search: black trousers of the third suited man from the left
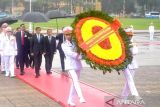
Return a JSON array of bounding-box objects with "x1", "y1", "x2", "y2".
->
[{"x1": 44, "y1": 53, "x2": 54, "y2": 72}]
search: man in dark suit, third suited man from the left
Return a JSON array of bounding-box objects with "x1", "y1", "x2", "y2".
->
[{"x1": 44, "y1": 29, "x2": 56, "y2": 74}]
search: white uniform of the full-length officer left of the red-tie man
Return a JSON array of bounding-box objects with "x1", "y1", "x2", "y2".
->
[{"x1": 1, "y1": 35, "x2": 17, "y2": 77}]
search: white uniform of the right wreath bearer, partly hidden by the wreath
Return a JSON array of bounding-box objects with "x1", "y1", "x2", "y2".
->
[{"x1": 121, "y1": 41, "x2": 139, "y2": 98}]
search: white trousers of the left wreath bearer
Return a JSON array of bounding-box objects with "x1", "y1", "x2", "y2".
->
[{"x1": 68, "y1": 70, "x2": 83, "y2": 101}]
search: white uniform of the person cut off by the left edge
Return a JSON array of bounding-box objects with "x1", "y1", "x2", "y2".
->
[{"x1": 0, "y1": 32, "x2": 5, "y2": 71}]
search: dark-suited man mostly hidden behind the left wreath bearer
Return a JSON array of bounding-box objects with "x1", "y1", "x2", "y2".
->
[{"x1": 56, "y1": 33, "x2": 65, "y2": 72}]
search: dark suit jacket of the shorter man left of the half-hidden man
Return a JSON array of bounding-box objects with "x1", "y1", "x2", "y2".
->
[{"x1": 44, "y1": 36, "x2": 56, "y2": 54}]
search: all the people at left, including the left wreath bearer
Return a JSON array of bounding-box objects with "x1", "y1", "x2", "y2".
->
[{"x1": 0, "y1": 23, "x2": 86, "y2": 106}]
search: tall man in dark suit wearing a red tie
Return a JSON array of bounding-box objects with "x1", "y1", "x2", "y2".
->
[{"x1": 16, "y1": 24, "x2": 30, "y2": 75}]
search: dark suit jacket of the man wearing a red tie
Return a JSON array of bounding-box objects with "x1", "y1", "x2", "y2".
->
[{"x1": 16, "y1": 31, "x2": 31, "y2": 53}]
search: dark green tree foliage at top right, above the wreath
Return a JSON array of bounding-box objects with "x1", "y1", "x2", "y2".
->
[{"x1": 102, "y1": 0, "x2": 160, "y2": 14}]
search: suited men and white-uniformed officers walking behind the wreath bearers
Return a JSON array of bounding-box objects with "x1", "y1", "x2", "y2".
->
[{"x1": 0, "y1": 23, "x2": 68, "y2": 78}]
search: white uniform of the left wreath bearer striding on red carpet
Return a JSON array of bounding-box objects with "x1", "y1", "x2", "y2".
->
[{"x1": 62, "y1": 40, "x2": 83, "y2": 102}]
